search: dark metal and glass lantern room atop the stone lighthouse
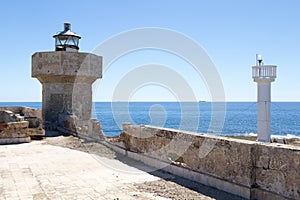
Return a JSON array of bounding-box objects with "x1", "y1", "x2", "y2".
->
[{"x1": 53, "y1": 23, "x2": 81, "y2": 52}]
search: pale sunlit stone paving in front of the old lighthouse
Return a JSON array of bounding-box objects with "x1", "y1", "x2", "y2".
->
[{"x1": 0, "y1": 141, "x2": 164, "y2": 200}]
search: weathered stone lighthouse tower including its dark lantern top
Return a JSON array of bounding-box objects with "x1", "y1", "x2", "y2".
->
[{"x1": 32, "y1": 23, "x2": 102, "y2": 137}]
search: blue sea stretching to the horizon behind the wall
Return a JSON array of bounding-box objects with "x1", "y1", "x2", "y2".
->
[{"x1": 0, "y1": 101, "x2": 300, "y2": 138}]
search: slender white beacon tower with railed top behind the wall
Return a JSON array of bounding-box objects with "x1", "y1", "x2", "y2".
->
[{"x1": 252, "y1": 54, "x2": 277, "y2": 142}]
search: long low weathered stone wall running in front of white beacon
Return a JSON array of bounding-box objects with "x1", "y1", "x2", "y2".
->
[{"x1": 120, "y1": 124, "x2": 300, "y2": 199}]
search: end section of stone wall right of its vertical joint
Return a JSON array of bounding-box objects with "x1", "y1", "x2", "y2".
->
[{"x1": 254, "y1": 144, "x2": 300, "y2": 199}]
